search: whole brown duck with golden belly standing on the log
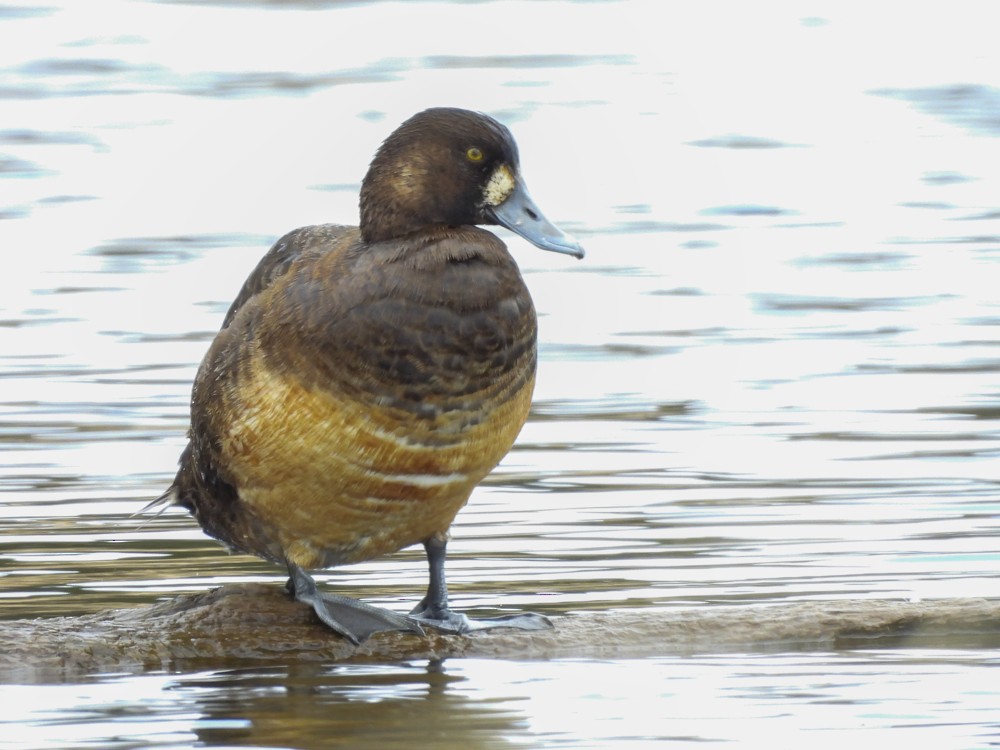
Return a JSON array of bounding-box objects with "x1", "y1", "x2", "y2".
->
[{"x1": 151, "y1": 107, "x2": 584, "y2": 644}]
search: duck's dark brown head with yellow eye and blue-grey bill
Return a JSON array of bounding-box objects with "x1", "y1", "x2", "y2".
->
[{"x1": 361, "y1": 108, "x2": 583, "y2": 258}]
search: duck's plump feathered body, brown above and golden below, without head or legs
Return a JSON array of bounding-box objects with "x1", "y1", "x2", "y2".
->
[{"x1": 175, "y1": 225, "x2": 536, "y2": 568}]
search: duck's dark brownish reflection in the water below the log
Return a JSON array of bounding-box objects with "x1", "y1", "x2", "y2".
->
[{"x1": 167, "y1": 662, "x2": 524, "y2": 748}]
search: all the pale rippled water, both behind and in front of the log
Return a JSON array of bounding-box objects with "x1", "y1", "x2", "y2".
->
[{"x1": 0, "y1": 0, "x2": 1000, "y2": 748}]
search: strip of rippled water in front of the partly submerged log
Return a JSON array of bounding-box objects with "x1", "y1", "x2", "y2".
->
[{"x1": 0, "y1": 649, "x2": 1000, "y2": 750}]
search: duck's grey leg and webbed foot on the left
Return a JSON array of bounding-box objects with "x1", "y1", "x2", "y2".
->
[{"x1": 287, "y1": 562, "x2": 424, "y2": 646}]
